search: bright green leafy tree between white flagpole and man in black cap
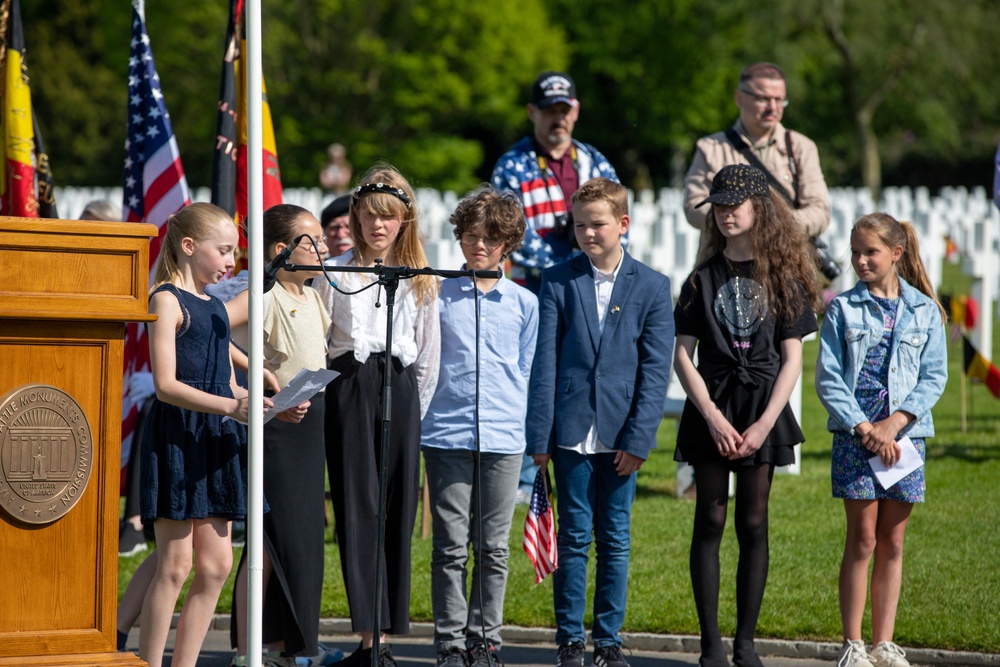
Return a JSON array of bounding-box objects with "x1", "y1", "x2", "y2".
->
[{"x1": 264, "y1": 0, "x2": 566, "y2": 191}]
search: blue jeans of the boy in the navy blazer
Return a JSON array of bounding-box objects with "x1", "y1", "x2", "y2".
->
[{"x1": 552, "y1": 449, "x2": 636, "y2": 648}]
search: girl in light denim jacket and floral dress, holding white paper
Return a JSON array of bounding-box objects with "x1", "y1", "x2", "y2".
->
[{"x1": 816, "y1": 213, "x2": 948, "y2": 667}]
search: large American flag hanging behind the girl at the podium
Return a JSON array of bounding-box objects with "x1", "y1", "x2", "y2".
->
[{"x1": 122, "y1": 0, "x2": 191, "y2": 478}]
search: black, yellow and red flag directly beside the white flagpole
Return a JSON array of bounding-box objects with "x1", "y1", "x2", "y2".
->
[{"x1": 212, "y1": 0, "x2": 282, "y2": 273}]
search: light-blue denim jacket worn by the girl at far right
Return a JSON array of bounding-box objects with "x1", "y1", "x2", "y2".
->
[{"x1": 816, "y1": 278, "x2": 948, "y2": 438}]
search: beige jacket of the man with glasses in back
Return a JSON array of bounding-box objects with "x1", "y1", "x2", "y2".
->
[{"x1": 684, "y1": 121, "x2": 830, "y2": 243}]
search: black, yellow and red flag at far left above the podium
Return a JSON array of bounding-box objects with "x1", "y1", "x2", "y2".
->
[{"x1": 0, "y1": 0, "x2": 59, "y2": 218}]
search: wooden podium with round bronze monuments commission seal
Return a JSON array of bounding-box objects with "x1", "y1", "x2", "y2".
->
[{"x1": 0, "y1": 217, "x2": 157, "y2": 667}]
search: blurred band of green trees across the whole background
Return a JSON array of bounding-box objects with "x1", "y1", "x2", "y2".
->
[{"x1": 22, "y1": 0, "x2": 1000, "y2": 196}]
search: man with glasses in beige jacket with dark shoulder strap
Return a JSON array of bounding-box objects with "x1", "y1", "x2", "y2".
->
[{"x1": 684, "y1": 63, "x2": 830, "y2": 245}]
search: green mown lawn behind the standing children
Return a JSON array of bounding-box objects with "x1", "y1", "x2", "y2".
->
[{"x1": 119, "y1": 267, "x2": 1000, "y2": 653}]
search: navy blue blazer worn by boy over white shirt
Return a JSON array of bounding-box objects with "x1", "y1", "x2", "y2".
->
[{"x1": 526, "y1": 252, "x2": 674, "y2": 459}]
